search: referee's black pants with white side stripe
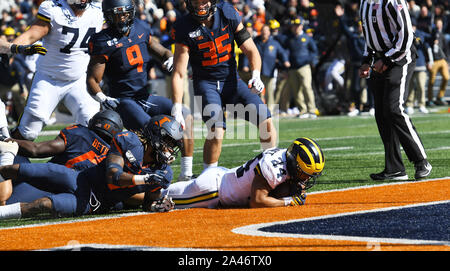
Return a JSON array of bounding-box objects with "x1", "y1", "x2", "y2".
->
[{"x1": 368, "y1": 53, "x2": 427, "y2": 173}]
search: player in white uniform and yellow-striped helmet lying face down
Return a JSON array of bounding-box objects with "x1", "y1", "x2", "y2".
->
[{"x1": 161, "y1": 137, "x2": 325, "y2": 209}]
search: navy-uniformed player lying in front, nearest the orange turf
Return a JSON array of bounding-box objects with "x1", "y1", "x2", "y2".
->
[{"x1": 0, "y1": 115, "x2": 183, "y2": 219}]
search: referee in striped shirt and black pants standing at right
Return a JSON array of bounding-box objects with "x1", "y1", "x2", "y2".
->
[{"x1": 359, "y1": 0, "x2": 432, "y2": 183}]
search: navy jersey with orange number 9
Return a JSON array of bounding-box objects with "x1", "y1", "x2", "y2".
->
[{"x1": 89, "y1": 19, "x2": 153, "y2": 98}]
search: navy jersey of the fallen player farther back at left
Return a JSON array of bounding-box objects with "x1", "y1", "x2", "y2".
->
[{"x1": 49, "y1": 125, "x2": 109, "y2": 170}]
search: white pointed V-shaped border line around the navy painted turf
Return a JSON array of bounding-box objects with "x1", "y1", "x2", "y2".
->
[{"x1": 231, "y1": 200, "x2": 450, "y2": 246}]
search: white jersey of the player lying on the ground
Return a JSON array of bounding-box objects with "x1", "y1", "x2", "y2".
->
[{"x1": 219, "y1": 148, "x2": 288, "y2": 206}]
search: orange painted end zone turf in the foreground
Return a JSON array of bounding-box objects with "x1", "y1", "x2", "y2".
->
[{"x1": 0, "y1": 179, "x2": 450, "y2": 251}]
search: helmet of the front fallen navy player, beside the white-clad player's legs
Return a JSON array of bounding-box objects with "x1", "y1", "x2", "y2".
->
[{"x1": 143, "y1": 115, "x2": 183, "y2": 164}]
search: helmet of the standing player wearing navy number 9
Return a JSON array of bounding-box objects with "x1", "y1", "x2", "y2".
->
[{"x1": 102, "y1": 0, "x2": 135, "y2": 35}]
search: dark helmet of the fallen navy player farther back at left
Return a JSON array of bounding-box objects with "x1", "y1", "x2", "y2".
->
[{"x1": 88, "y1": 110, "x2": 123, "y2": 143}]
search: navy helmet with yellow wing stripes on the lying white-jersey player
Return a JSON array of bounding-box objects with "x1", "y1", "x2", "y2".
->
[{"x1": 286, "y1": 137, "x2": 325, "y2": 190}]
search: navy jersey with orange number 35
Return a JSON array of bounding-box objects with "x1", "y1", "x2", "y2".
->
[{"x1": 172, "y1": 2, "x2": 241, "y2": 80}]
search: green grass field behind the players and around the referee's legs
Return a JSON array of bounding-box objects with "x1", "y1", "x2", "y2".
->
[{"x1": 0, "y1": 107, "x2": 450, "y2": 230}]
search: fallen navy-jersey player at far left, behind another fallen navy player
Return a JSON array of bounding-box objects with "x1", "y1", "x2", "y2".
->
[{"x1": 0, "y1": 110, "x2": 123, "y2": 205}]
